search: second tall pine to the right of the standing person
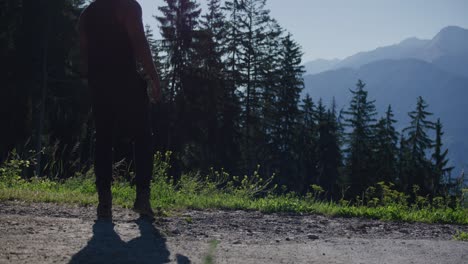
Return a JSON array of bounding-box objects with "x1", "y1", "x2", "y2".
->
[{"x1": 199, "y1": 0, "x2": 240, "y2": 170}]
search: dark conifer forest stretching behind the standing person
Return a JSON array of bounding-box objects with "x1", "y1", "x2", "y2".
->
[{"x1": 0, "y1": 0, "x2": 457, "y2": 200}]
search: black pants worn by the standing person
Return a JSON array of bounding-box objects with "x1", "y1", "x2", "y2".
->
[{"x1": 90, "y1": 75, "x2": 153, "y2": 189}]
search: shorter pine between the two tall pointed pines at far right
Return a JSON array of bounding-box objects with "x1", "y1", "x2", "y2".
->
[{"x1": 374, "y1": 105, "x2": 398, "y2": 183}]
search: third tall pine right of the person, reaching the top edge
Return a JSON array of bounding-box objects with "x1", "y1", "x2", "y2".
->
[{"x1": 225, "y1": 0, "x2": 277, "y2": 171}]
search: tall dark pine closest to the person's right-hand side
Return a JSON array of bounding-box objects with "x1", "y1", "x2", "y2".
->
[{"x1": 155, "y1": 0, "x2": 204, "y2": 171}]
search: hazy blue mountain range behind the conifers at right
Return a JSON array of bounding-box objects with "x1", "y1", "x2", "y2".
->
[{"x1": 303, "y1": 26, "x2": 468, "y2": 176}]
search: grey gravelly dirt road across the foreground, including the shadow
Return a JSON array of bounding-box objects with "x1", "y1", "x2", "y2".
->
[{"x1": 0, "y1": 202, "x2": 468, "y2": 264}]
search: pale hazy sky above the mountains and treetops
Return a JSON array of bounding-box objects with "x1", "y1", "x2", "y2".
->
[{"x1": 137, "y1": 0, "x2": 468, "y2": 61}]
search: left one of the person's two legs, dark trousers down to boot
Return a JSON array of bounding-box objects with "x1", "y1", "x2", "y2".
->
[{"x1": 94, "y1": 106, "x2": 113, "y2": 218}]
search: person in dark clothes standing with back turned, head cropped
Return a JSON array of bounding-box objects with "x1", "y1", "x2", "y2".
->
[{"x1": 79, "y1": 0, "x2": 161, "y2": 219}]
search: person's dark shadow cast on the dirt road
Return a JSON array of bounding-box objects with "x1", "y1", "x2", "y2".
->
[{"x1": 69, "y1": 219, "x2": 190, "y2": 264}]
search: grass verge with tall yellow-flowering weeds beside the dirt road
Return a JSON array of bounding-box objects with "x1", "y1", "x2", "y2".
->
[{"x1": 0, "y1": 157, "x2": 468, "y2": 225}]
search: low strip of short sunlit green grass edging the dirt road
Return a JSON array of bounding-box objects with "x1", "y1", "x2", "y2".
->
[{"x1": 0, "y1": 173, "x2": 468, "y2": 225}]
